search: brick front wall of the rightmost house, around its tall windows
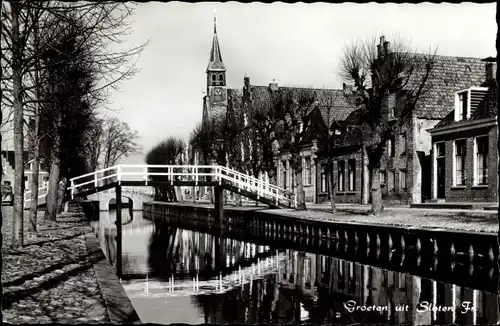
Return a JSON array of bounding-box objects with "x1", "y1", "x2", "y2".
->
[{"x1": 431, "y1": 126, "x2": 498, "y2": 202}]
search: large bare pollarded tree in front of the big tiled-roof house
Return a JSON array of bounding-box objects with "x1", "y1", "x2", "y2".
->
[{"x1": 341, "y1": 37, "x2": 435, "y2": 215}]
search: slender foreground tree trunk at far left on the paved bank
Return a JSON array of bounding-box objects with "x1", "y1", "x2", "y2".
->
[{"x1": 10, "y1": 2, "x2": 24, "y2": 248}]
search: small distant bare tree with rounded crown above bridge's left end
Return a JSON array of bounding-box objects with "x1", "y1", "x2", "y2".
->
[{"x1": 102, "y1": 117, "x2": 140, "y2": 168}]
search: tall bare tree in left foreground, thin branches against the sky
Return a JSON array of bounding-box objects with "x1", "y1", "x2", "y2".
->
[{"x1": 2, "y1": 1, "x2": 144, "y2": 241}]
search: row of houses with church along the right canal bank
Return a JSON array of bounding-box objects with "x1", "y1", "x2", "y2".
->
[{"x1": 203, "y1": 19, "x2": 498, "y2": 204}]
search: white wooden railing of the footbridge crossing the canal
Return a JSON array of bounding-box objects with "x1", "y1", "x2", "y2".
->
[{"x1": 70, "y1": 164, "x2": 297, "y2": 207}]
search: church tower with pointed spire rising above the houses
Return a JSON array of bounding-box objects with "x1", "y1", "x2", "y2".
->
[{"x1": 203, "y1": 17, "x2": 227, "y2": 121}]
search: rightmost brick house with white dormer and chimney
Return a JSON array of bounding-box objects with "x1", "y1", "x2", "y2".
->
[{"x1": 429, "y1": 58, "x2": 498, "y2": 202}]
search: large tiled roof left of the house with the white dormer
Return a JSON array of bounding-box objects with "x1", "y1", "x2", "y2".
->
[{"x1": 408, "y1": 54, "x2": 485, "y2": 119}]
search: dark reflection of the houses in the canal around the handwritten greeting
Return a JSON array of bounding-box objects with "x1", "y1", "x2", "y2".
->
[{"x1": 192, "y1": 250, "x2": 499, "y2": 325}]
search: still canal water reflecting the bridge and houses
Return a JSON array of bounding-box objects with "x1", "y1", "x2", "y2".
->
[{"x1": 92, "y1": 209, "x2": 500, "y2": 325}]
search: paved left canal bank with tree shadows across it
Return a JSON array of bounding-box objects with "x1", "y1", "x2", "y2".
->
[{"x1": 2, "y1": 207, "x2": 140, "y2": 324}]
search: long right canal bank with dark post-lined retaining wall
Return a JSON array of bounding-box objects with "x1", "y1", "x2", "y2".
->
[{"x1": 144, "y1": 202, "x2": 498, "y2": 265}]
